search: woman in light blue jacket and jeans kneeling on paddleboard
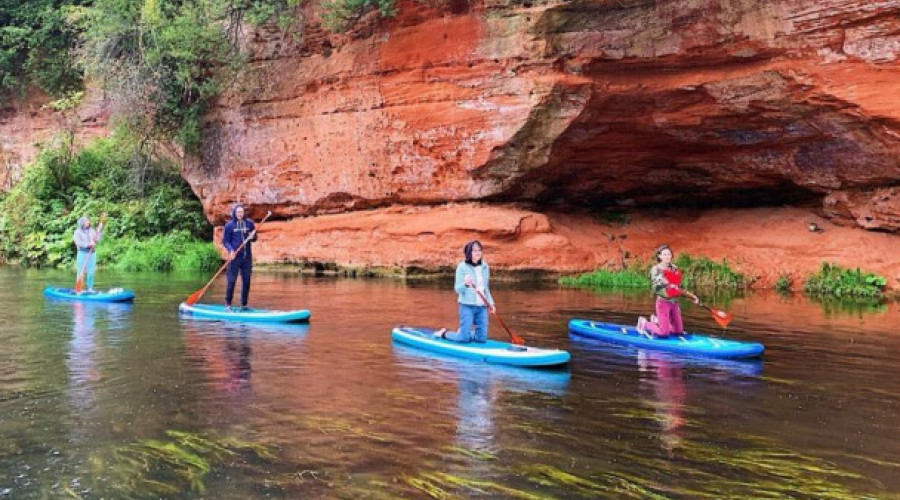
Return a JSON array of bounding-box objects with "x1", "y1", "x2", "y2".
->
[{"x1": 435, "y1": 240, "x2": 497, "y2": 343}]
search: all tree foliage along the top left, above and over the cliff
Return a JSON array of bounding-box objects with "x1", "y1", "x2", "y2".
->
[{"x1": 0, "y1": 0, "x2": 396, "y2": 153}]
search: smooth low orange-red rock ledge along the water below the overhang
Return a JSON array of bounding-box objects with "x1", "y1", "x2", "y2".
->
[{"x1": 227, "y1": 203, "x2": 900, "y2": 290}]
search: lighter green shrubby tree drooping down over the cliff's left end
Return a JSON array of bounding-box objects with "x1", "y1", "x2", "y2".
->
[{"x1": 81, "y1": 0, "x2": 299, "y2": 153}]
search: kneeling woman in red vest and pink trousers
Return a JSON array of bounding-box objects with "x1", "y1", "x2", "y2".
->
[{"x1": 637, "y1": 245, "x2": 700, "y2": 337}]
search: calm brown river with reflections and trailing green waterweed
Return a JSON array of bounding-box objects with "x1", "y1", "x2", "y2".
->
[{"x1": 0, "y1": 267, "x2": 900, "y2": 499}]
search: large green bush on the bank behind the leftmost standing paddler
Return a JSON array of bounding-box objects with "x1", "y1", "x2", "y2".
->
[{"x1": 0, "y1": 133, "x2": 212, "y2": 269}]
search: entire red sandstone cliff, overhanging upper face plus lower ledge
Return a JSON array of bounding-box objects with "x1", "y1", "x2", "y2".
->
[{"x1": 0, "y1": 0, "x2": 900, "y2": 286}]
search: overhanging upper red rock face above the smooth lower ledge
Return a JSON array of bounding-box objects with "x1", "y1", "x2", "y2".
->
[{"x1": 185, "y1": 0, "x2": 900, "y2": 222}]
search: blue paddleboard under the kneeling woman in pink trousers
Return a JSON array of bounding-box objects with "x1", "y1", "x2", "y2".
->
[{"x1": 569, "y1": 319, "x2": 766, "y2": 359}]
